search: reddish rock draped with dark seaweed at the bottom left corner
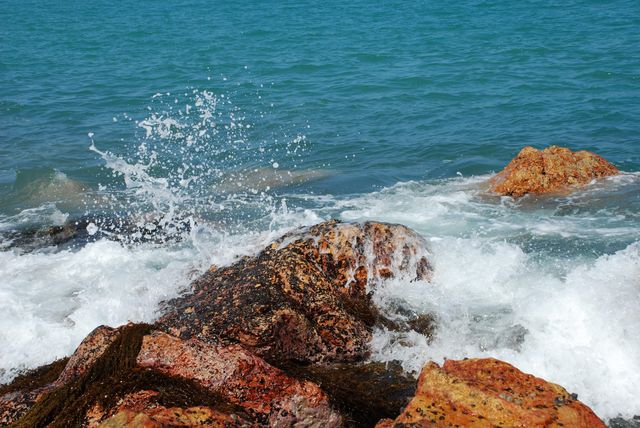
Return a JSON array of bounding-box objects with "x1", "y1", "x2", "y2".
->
[{"x1": 0, "y1": 324, "x2": 342, "y2": 427}]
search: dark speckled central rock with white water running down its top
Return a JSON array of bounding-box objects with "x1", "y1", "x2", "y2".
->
[{"x1": 158, "y1": 221, "x2": 431, "y2": 364}]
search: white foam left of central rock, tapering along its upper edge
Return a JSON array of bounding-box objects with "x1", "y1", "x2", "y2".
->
[{"x1": 0, "y1": 203, "x2": 323, "y2": 383}]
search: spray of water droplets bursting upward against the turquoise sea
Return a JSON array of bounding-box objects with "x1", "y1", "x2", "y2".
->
[{"x1": 87, "y1": 89, "x2": 316, "y2": 242}]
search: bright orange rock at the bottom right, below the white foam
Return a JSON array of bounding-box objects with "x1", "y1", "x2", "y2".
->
[{"x1": 377, "y1": 358, "x2": 605, "y2": 428}]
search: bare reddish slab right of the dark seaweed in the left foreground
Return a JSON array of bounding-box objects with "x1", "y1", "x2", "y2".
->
[{"x1": 137, "y1": 332, "x2": 341, "y2": 427}]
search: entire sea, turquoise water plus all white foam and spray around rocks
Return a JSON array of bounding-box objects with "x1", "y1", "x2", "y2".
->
[{"x1": 0, "y1": 0, "x2": 640, "y2": 418}]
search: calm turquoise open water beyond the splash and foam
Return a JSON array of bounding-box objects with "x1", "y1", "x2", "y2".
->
[{"x1": 0, "y1": 1, "x2": 640, "y2": 194}]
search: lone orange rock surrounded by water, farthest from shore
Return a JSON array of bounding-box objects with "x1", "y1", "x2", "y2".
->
[{"x1": 490, "y1": 146, "x2": 619, "y2": 197}]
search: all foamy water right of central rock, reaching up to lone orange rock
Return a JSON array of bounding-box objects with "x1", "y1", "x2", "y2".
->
[{"x1": 292, "y1": 173, "x2": 640, "y2": 418}]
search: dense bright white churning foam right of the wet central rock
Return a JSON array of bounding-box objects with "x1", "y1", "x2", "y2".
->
[{"x1": 373, "y1": 238, "x2": 640, "y2": 418}]
